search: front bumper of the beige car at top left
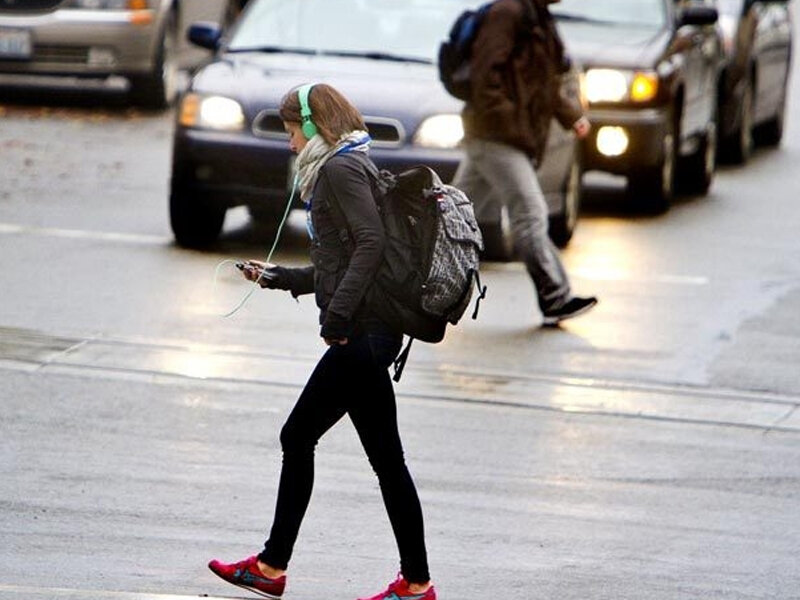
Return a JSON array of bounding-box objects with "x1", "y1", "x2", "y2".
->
[{"x1": 0, "y1": 9, "x2": 158, "y2": 77}]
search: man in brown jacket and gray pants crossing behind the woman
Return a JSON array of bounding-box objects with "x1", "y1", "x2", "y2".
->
[{"x1": 453, "y1": 0, "x2": 597, "y2": 326}]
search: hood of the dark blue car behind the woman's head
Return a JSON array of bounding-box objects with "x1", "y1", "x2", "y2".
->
[{"x1": 191, "y1": 52, "x2": 462, "y2": 118}]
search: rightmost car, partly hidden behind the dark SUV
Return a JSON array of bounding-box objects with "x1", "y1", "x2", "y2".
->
[{"x1": 717, "y1": 0, "x2": 792, "y2": 163}]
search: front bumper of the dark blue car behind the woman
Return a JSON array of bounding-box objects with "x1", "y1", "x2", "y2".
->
[{"x1": 172, "y1": 126, "x2": 462, "y2": 212}]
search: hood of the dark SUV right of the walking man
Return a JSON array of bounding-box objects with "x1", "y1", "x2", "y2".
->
[{"x1": 559, "y1": 23, "x2": 670, "y2": 69}]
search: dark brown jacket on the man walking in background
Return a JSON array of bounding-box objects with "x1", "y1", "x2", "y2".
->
[{"x1": 463, "y1": 0, "x2": 583, "y2": 164}]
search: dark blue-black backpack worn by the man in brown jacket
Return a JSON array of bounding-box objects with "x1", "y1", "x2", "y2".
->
[{"x1": 439, "y1": 2, "x2": 493, "y2": 100}]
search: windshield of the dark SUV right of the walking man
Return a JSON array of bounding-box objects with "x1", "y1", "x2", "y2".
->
[{"x1": 550, "y1": 0, "x2": 667, "y2": 28}]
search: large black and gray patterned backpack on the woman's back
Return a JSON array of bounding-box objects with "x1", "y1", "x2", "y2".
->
[{"x1": 328, "y1": 152, "x2": 486, "y2": 381}]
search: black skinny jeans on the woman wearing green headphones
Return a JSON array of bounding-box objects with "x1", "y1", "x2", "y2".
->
[{"x1": 258, "y1": 334, "x2": 430, "y2": 583}]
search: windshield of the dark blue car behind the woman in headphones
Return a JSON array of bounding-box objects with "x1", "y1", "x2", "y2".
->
[{"x1": 228, "y1": 0, "x2": 480, "y2": 63}]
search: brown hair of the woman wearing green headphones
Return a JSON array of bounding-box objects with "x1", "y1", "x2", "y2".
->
[{"x1": 278, "y1": 83, "x2": 367, "y2": 146}]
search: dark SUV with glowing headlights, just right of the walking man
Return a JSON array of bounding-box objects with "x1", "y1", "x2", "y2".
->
[{"x1": 550, "y1": 0, "x2": 723, "y2": 212}]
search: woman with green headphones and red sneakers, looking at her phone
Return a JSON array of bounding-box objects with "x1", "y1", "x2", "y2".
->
[{"x1": 203, "y1": 84, "x2": 436, "y2": 600}]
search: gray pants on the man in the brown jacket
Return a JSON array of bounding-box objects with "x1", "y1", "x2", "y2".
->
[{"x1": 453, "y1": 140, "x2": 570, "y2": 312}]
